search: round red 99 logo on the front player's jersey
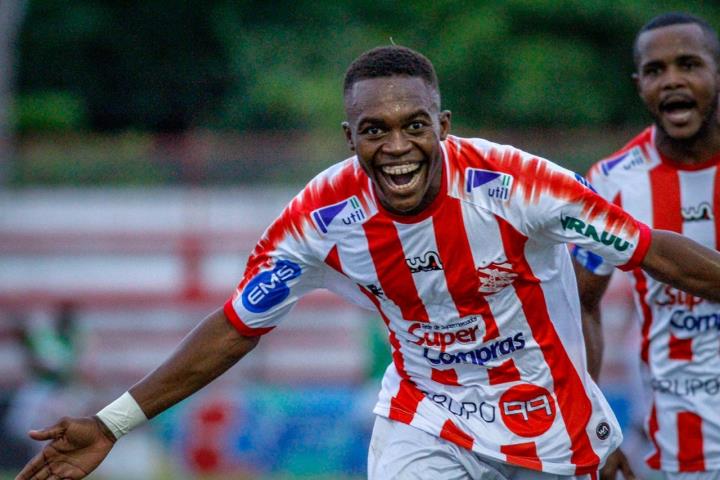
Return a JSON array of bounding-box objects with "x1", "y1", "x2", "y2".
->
[{"x1": 499, "y1": 383, "x2": 556, "y2": 437}]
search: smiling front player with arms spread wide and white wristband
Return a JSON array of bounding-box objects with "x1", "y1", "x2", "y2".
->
[{"x1": 18, "y1": 46, "x2": 720, "y2": 480}]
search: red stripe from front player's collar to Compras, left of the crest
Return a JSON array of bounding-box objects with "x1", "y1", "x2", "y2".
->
[{"x1": 433, "y1": 198, "x2": 500, "y2": 342}]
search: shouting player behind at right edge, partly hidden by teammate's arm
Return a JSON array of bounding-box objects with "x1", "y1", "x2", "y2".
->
[{"x1": 574, "y1": 13, "x2": 720, "y2": 480}]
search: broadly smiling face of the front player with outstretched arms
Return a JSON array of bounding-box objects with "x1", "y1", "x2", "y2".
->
[{"x1": 343, "y1": 76, "x2": 450, "y2": 215}]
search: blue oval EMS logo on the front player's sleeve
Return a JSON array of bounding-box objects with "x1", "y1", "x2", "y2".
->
[{"x1": 242, "y1": 260, "x2": 302, "y2": 313}]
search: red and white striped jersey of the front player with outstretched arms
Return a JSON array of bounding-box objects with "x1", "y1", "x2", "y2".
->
[{"x1": 225, "y1": 137, "x2": 650, "y2": 475}]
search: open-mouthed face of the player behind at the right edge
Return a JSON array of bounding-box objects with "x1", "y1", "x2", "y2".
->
[{"x1": 635, "y1": 24, "x2": 720, "y2": 140}]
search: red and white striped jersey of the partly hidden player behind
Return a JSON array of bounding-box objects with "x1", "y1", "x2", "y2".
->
[{"x1": 576, "y1": 127, "x2": 720, "y2": 472}]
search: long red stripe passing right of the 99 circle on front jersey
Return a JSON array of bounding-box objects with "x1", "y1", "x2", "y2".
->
[{"x1": 496, "y1": 216, "x2": 600, "y2": 475}]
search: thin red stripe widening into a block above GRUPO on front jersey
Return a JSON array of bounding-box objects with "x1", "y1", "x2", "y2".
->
[{"x1": 360, "y1": 287, "x2": 425, "y2": 424}]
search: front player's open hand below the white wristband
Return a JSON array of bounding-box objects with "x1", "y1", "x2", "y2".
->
[{"x1": 15, "y1": 417, "x2": 115, "y2": 480}]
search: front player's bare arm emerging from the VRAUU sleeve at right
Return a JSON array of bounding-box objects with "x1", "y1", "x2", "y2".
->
[{"x1": 640, "y1": 230, "x2": 720, "y2": 302}]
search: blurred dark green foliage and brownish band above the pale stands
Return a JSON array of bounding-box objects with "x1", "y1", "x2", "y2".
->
[{"x1": 11, "y1": 0, "x2": 720, "y2": 185}]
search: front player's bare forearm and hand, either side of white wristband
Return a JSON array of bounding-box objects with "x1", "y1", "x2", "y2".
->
[{"x1": 16, "y1": 309, "x2": 259, "y2": 480}]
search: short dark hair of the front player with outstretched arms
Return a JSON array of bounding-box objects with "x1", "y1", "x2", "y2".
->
[{"x1": 343, "y1": 45, "x2": 439, "y2": 94}]
